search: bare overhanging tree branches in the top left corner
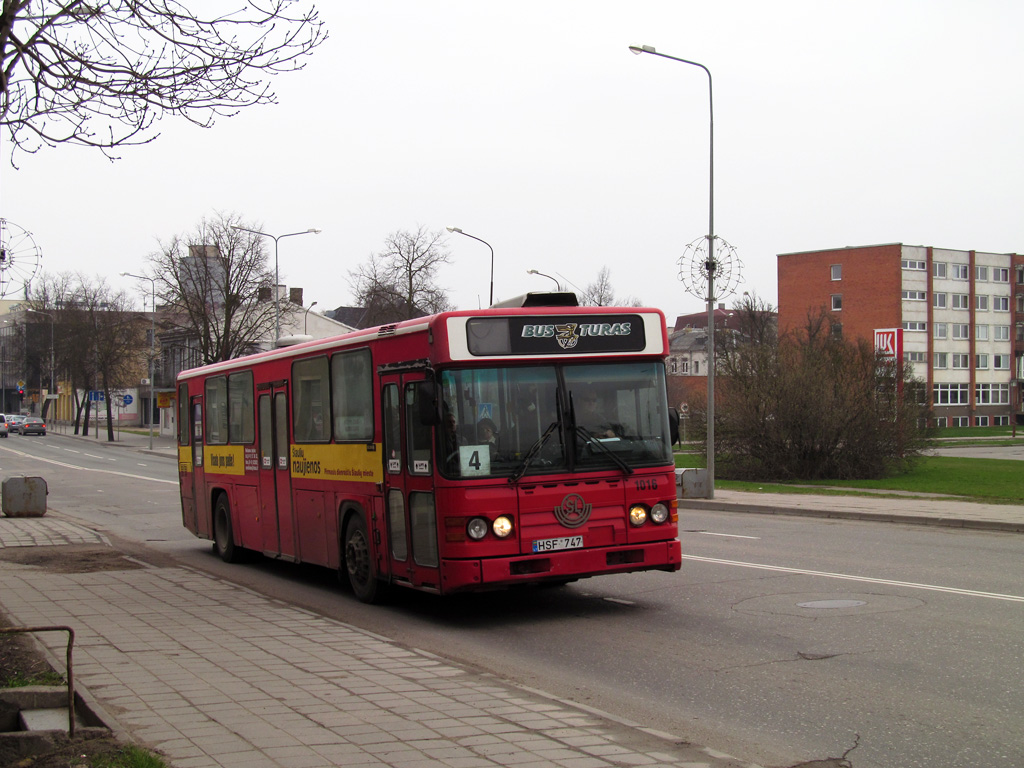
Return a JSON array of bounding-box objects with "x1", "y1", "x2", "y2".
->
[{"x1": 0, "y1": 0, "x2": 327, "y2": 159}]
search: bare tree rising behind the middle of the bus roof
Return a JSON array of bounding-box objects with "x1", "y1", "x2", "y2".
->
[{"x1": 348, "y1": 226, "x2": 454, "y2": 326}]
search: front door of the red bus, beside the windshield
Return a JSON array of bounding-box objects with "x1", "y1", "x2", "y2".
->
[{"x1": 378, "y1": 373, "x2": 440, "y2": 590}]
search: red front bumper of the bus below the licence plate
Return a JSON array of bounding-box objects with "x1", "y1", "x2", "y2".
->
[{"x1": 441, "y1": 540, "x2": 682, "y2": 594}]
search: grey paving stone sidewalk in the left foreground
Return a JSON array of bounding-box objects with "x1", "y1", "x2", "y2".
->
[{"x1": 0, "y1": 516, "x2": 756, "y2": 768}]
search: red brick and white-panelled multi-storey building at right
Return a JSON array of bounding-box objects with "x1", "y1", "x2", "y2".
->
[{"x1": 778, "y1": 243, "x2": 1024, "y2": 426}]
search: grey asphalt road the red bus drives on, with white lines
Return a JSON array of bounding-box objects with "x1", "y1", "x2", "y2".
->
[{"x1": 0, "y1": 437, "x2": 1024, "y2": 768}]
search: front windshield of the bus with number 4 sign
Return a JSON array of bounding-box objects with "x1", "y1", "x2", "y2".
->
[{"x1": 437, "y1": 361, "x2": 672, "y2": 479}]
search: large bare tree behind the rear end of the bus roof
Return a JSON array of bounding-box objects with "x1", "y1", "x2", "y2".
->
[{"x1": 150, "y1": 213, "x2": 276, "y2": 365}]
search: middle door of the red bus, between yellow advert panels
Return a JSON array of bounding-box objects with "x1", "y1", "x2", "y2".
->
[{"x1": 257, "y1": 383, "x2": 295, "y2": 559}]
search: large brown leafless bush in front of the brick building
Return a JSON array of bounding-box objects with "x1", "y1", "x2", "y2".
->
[{"x1": 708, "y1": 302, "x2": 928, "y2": 480}]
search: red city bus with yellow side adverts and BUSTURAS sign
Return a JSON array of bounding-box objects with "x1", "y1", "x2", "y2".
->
[{"x1": 177, "y1": 294, "x2": 681, "y2": 602}]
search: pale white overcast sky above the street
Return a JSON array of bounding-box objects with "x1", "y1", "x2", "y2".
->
[{"x1": 0, "y1": 0, "x2": 1024, "y2": 319}]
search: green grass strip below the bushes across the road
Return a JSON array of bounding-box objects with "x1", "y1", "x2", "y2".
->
[{"x1": 676, "y1": 454, "x2": 1024, "y2": 504}]
